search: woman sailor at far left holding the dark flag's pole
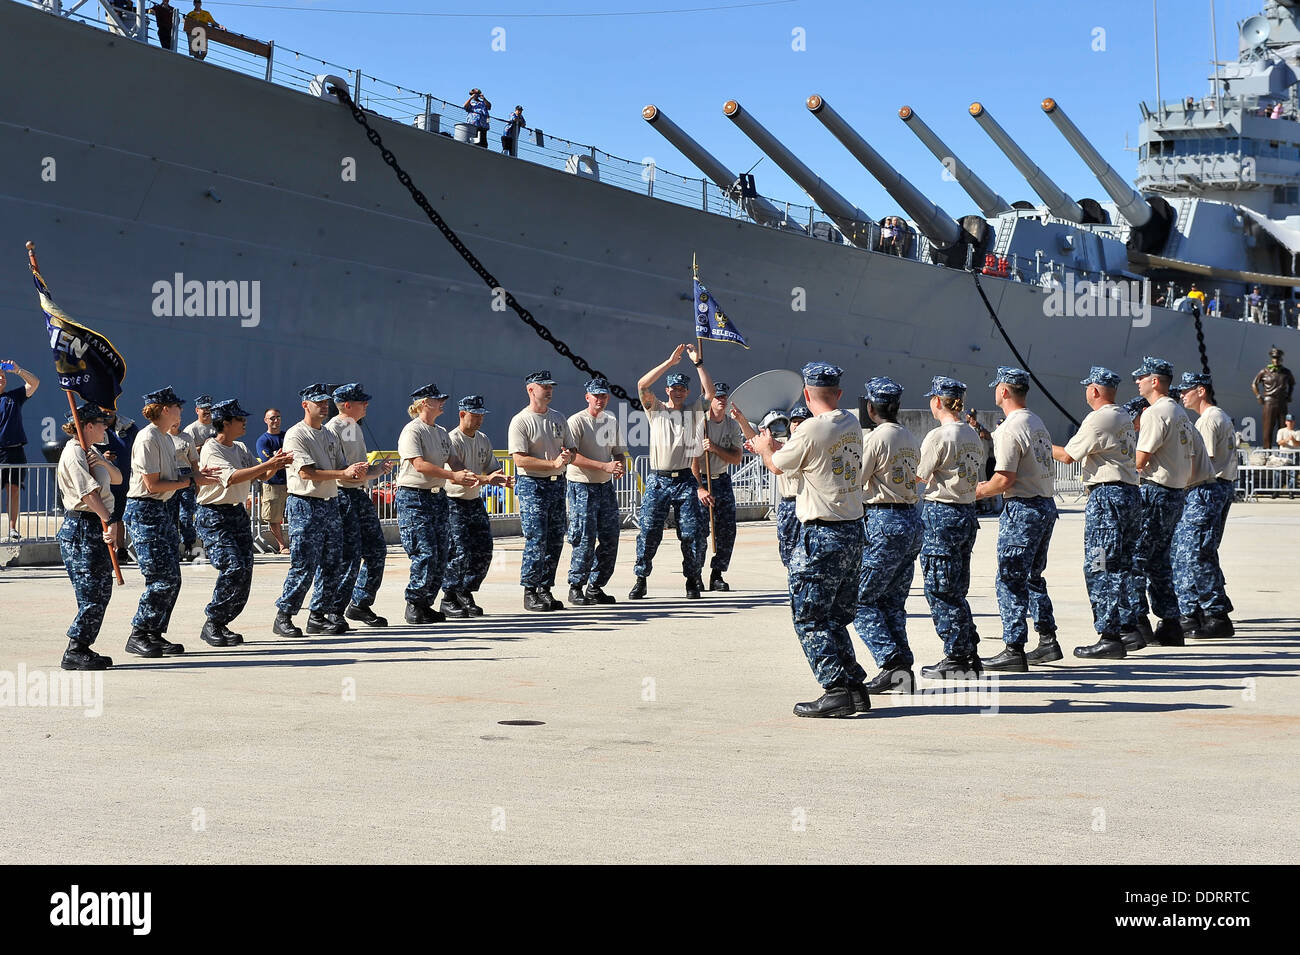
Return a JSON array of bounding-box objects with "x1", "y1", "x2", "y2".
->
[{"x1": 56, "y1": 401, "x2": 122, "y2": 670}]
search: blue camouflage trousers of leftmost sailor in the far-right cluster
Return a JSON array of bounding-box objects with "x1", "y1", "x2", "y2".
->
[{"x1": 1083, "y1": 483, "x2": 1141, "y2": 637}]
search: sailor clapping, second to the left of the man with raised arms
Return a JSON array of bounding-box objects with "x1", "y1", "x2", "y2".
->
[{"x1": 506, "y1": 370, "x2": 573, "y2": 612}]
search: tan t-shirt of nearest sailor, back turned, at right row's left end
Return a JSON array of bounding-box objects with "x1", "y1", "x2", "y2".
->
[{"x1": 772, "y1": 409, "x2": 862, "y2": 521}]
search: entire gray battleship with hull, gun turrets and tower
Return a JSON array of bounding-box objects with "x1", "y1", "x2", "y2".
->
[{"x1": 0, "y1": 0, "x2": 1300, "y2": 444}]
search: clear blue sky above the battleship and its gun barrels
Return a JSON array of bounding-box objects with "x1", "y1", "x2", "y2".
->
[{"x1": 152, "y1": 0, "x2": 1262, "y2": 217}]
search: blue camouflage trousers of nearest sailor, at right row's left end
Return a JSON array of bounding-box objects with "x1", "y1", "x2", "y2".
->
[{"x1": 790, "y1": 521, "x2": 867, "y2": 687}]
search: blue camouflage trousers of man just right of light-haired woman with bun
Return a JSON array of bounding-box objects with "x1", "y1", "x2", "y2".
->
[{"x1": 996, "y1": 498, "x2": 1057, "y2": 646}]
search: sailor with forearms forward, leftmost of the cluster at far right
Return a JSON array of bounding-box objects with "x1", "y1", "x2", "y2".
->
[{"x1": 1050, "y1": 365, "x2": 1147, "y2": 663}]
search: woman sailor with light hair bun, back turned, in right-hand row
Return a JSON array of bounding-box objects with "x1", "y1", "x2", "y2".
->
[{"x1": 917, "y1": 376, "x2": 984, "y2": 680}]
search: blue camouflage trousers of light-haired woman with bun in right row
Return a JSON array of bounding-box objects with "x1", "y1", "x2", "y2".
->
[{"x1": 920, "y1": 500, "x2": 979, "y2": 657}]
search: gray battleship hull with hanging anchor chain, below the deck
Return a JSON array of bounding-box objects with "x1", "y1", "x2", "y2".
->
[{"x1": 0, "y1": 3, "x2": 1291, "y2": 447}]
